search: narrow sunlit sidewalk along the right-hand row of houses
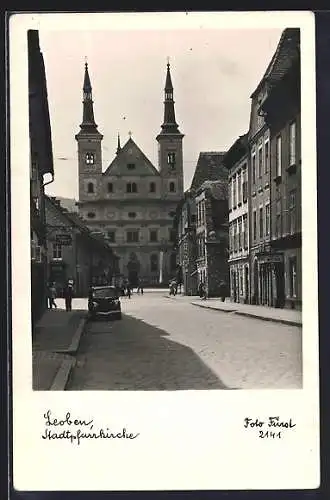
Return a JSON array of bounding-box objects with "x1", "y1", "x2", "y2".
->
[{"x1": 166, "y1": 295, "x2": 302, "y2": 327}]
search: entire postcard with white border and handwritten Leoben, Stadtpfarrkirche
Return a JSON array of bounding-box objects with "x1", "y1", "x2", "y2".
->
[{"x1": 10, "y1": 12, "x2": 319, "y2": 491}]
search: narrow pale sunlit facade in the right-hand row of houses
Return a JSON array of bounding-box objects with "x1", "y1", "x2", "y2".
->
[{"x1": 224, "y1": 134, "x2": 250, "y2": 304}]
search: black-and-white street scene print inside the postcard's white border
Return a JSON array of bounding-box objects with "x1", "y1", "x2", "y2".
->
[{"x1": 27, "y1": 23, "x2": 302, "y2": 391}]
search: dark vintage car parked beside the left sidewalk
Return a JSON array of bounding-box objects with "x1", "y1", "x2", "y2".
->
[{"x1": 88, "y1": 286, "x2": 121, "y2": 319}]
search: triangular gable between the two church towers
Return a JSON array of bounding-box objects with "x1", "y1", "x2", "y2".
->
[{"x1": 104, "y1": 138, "x2": 159, "y2": 177}]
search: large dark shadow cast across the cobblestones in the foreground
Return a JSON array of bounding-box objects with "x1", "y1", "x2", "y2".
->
[{"x1": 66, "y1": 314, "x2": 235, "y2": 391}]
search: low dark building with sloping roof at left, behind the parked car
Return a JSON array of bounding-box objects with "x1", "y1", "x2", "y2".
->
[{"x1": 45, "y1": 197, "x2": 118, "y2": 297}]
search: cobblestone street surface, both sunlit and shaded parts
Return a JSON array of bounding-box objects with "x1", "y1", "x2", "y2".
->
[{"x1": 67, "y1": 294, "x2": 302, "y2": 390}]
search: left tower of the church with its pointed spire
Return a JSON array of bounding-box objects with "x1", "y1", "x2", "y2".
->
[{"x1": 75, "y1": 62, "x2": 103, "y2": 202}]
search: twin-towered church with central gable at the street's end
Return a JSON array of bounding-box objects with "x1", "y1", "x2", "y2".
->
[{"x1": 75, "y1": 63, "x2": 184, "y2": 286}]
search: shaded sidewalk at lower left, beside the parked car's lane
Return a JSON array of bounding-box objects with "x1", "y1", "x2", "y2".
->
[{"x1": 32, "y1": 299, "x2": 86, "y2": 391}]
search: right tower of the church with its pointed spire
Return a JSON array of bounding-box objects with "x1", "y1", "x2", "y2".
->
[{"x1": 156, "y1": 62, "x2": 184, "y2": 200}]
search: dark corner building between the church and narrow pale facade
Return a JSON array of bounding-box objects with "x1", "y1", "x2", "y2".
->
[{"x1": 195, "y1": 179, "x2": 229, "y2": 297}]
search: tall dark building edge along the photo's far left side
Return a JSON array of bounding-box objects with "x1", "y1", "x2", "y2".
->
[{"x1": 28, "y1": 30, "x2": 54, "y2": 324}]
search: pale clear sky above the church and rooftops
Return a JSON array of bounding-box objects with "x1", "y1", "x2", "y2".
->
[{"x1": 39, "y1": 29, "x2": 282, "y2": 199}]
